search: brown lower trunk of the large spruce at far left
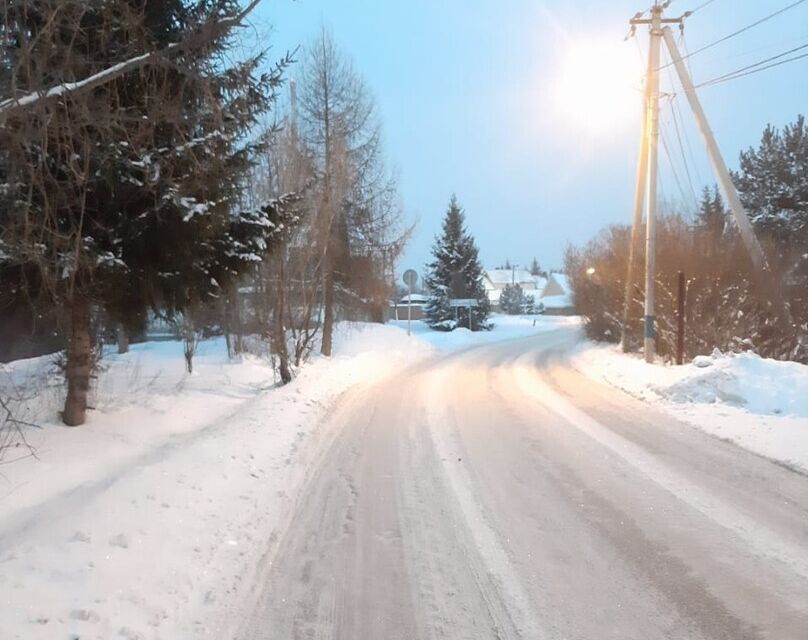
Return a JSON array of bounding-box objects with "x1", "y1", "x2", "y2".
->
[{"x1": 62, "y1": 294, "x2": 92, "y2": 427}]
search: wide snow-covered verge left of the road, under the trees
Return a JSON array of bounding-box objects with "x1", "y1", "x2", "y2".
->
[{"x1": 0, "y1": 324, "x2": 434, "y2": 640}]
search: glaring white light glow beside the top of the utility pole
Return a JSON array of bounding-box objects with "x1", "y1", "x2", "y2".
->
[{"x1": 551, "y1": 42, "x2": 641, "y2": 137}]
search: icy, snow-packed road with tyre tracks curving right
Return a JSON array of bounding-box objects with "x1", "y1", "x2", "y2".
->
[{"x1": 239, "y1": 330, "x2": 808, "y2": 640}]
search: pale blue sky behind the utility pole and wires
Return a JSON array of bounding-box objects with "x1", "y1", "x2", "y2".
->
[{"x1": 252, "y1": 0, "x2": 808, "y2": 271}]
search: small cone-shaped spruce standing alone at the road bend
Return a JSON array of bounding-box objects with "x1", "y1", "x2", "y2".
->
[{"x1": 424, "y1": 195, "x2": 490, "y2": 331}]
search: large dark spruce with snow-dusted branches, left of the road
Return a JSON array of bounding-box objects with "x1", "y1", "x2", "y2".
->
[{"x1": 0, "y1": 0, "x2": 296, "y2": 425}]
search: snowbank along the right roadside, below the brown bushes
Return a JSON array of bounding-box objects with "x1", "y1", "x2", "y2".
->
[{"x1": 572, "y1": 343, "x2": 808, "y2": 471}]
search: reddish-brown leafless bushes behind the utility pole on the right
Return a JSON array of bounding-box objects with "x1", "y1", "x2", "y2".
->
[{"x1": 565, "y1": 215, "x2": 808, "y2": 362}]
